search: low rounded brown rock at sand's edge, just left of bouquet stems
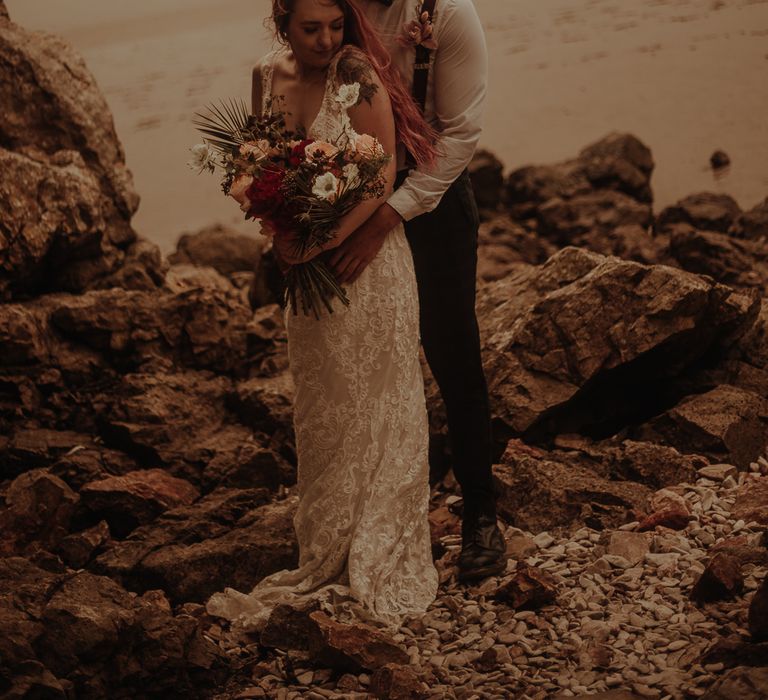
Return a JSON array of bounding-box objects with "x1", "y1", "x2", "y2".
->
[{"x1": 168, "y1": 224, "x2": 264, "y2": 276}]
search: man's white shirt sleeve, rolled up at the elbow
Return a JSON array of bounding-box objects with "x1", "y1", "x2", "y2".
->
[{"x1": 387, "y1": 0, "x2": 488, "y2": 221}]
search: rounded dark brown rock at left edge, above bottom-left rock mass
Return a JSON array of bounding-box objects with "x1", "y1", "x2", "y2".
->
[{"x1": 0, "y1": 469, "x2": 79, "y2": 556}]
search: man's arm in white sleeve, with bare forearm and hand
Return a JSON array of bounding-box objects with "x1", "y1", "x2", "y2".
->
[{"x1": 330, "y1": 0, "x2": 488, "y2": 284}]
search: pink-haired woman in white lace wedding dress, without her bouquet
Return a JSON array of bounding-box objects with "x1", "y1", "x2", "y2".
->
[{"x1": 206, "y1": 0, "x2": 438, "y2": 631}]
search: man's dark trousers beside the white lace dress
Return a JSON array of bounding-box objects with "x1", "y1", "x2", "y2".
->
[{"x1": 397, "y1": 170, "x2": 496, "y2": 515}]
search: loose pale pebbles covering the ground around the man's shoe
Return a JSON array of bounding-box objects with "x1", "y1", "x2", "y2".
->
[{"x1": 206, "y1": 458, "x2": 768, "y2": 700}]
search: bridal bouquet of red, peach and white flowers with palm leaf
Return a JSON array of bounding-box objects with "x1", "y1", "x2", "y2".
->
[{"x1": 189, "y1": 95, "x2": 389, "y2": 318}]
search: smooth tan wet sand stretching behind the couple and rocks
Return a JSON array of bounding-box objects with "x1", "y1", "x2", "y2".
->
[{"x1": 6, "y1": 0, "x2": 768, "y2": 252}]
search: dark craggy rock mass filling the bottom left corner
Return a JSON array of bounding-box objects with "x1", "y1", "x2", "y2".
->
[{"x1": 0, "y1": 557, "x2": 225, "y2": 697}]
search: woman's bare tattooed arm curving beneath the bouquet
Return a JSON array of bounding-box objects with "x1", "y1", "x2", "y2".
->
[{"x1": 281, "y1": 51, "x2": 397, "y2": 263}]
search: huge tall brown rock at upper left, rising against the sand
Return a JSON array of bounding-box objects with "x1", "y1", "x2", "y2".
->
[{"x1": 0, "y1": 16, "x2": 138, "y2": 299}]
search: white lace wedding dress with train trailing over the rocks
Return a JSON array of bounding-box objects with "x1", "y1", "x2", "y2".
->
[{"x1": 206, "y1": 46, "x2": 438, "y2": 631}]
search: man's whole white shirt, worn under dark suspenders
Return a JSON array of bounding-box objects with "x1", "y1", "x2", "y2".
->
[{"x1": 360, "y1": 0, "x2": 488, "y2": 221}]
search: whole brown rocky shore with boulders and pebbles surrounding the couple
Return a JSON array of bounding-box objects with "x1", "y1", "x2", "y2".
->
[{"x1": 0, "y1": 5, "x2": 768, "y2": 700}]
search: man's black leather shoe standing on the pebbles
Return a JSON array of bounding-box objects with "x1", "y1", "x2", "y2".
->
[{"x1": 459, "y1": 514, "x2": 507, "y2": 581}]
